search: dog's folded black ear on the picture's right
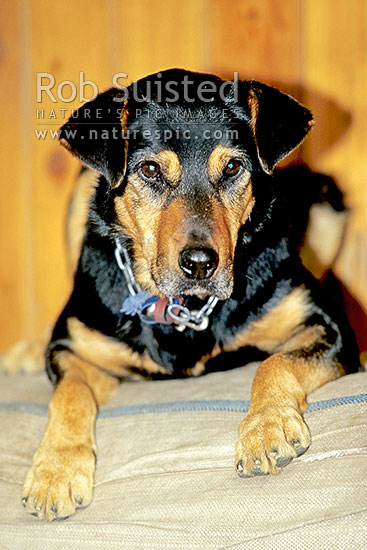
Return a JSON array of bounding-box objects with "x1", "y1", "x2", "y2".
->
[{"x1": 244, "y1": 81, "x2": 313, "y2": 174}]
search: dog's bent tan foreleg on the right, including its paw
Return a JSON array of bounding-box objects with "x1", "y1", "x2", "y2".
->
[{"x1": 236, "y1": 329, "x2": 340, "y2": 477}]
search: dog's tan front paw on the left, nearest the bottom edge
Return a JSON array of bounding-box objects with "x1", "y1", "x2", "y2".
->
[{"x1": 22, "y1": 445, "x2": 95, "y2": 521}]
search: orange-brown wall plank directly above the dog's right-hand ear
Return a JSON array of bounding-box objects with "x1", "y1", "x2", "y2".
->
[{"x1": 208, "y1": 0, "x2": 300, "y2": 84}]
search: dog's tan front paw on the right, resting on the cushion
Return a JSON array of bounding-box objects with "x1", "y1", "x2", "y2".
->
[{"x1": 235, "y1": 406, "x2": 311, "y2": 477}]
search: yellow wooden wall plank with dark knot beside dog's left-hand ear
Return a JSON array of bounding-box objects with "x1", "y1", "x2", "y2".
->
[{"x1": 30, "y1": 0, "x2": 116, "y2": 333}]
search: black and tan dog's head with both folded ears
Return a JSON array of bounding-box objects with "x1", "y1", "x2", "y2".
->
[{"x1": 60, "y1": 69, "x2": 312, "y2": 299}]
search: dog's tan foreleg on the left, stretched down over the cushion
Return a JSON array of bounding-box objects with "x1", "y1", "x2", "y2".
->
[{"x1": 22, "y1": 351, "x2": 118, "y2": 521}]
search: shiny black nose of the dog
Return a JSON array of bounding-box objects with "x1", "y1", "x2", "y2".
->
[{"x1": 178, "y1": 248, "x2": 219, "y2": 279}]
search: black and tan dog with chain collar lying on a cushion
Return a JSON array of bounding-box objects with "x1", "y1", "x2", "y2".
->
[{"x1": 23, "y1": 70, "x2": 358, "y2": 520}]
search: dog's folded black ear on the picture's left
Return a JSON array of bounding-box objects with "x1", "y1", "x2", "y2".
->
[{"x1": 59, "y1": 88, "x2": 128, "y2": 187}]
